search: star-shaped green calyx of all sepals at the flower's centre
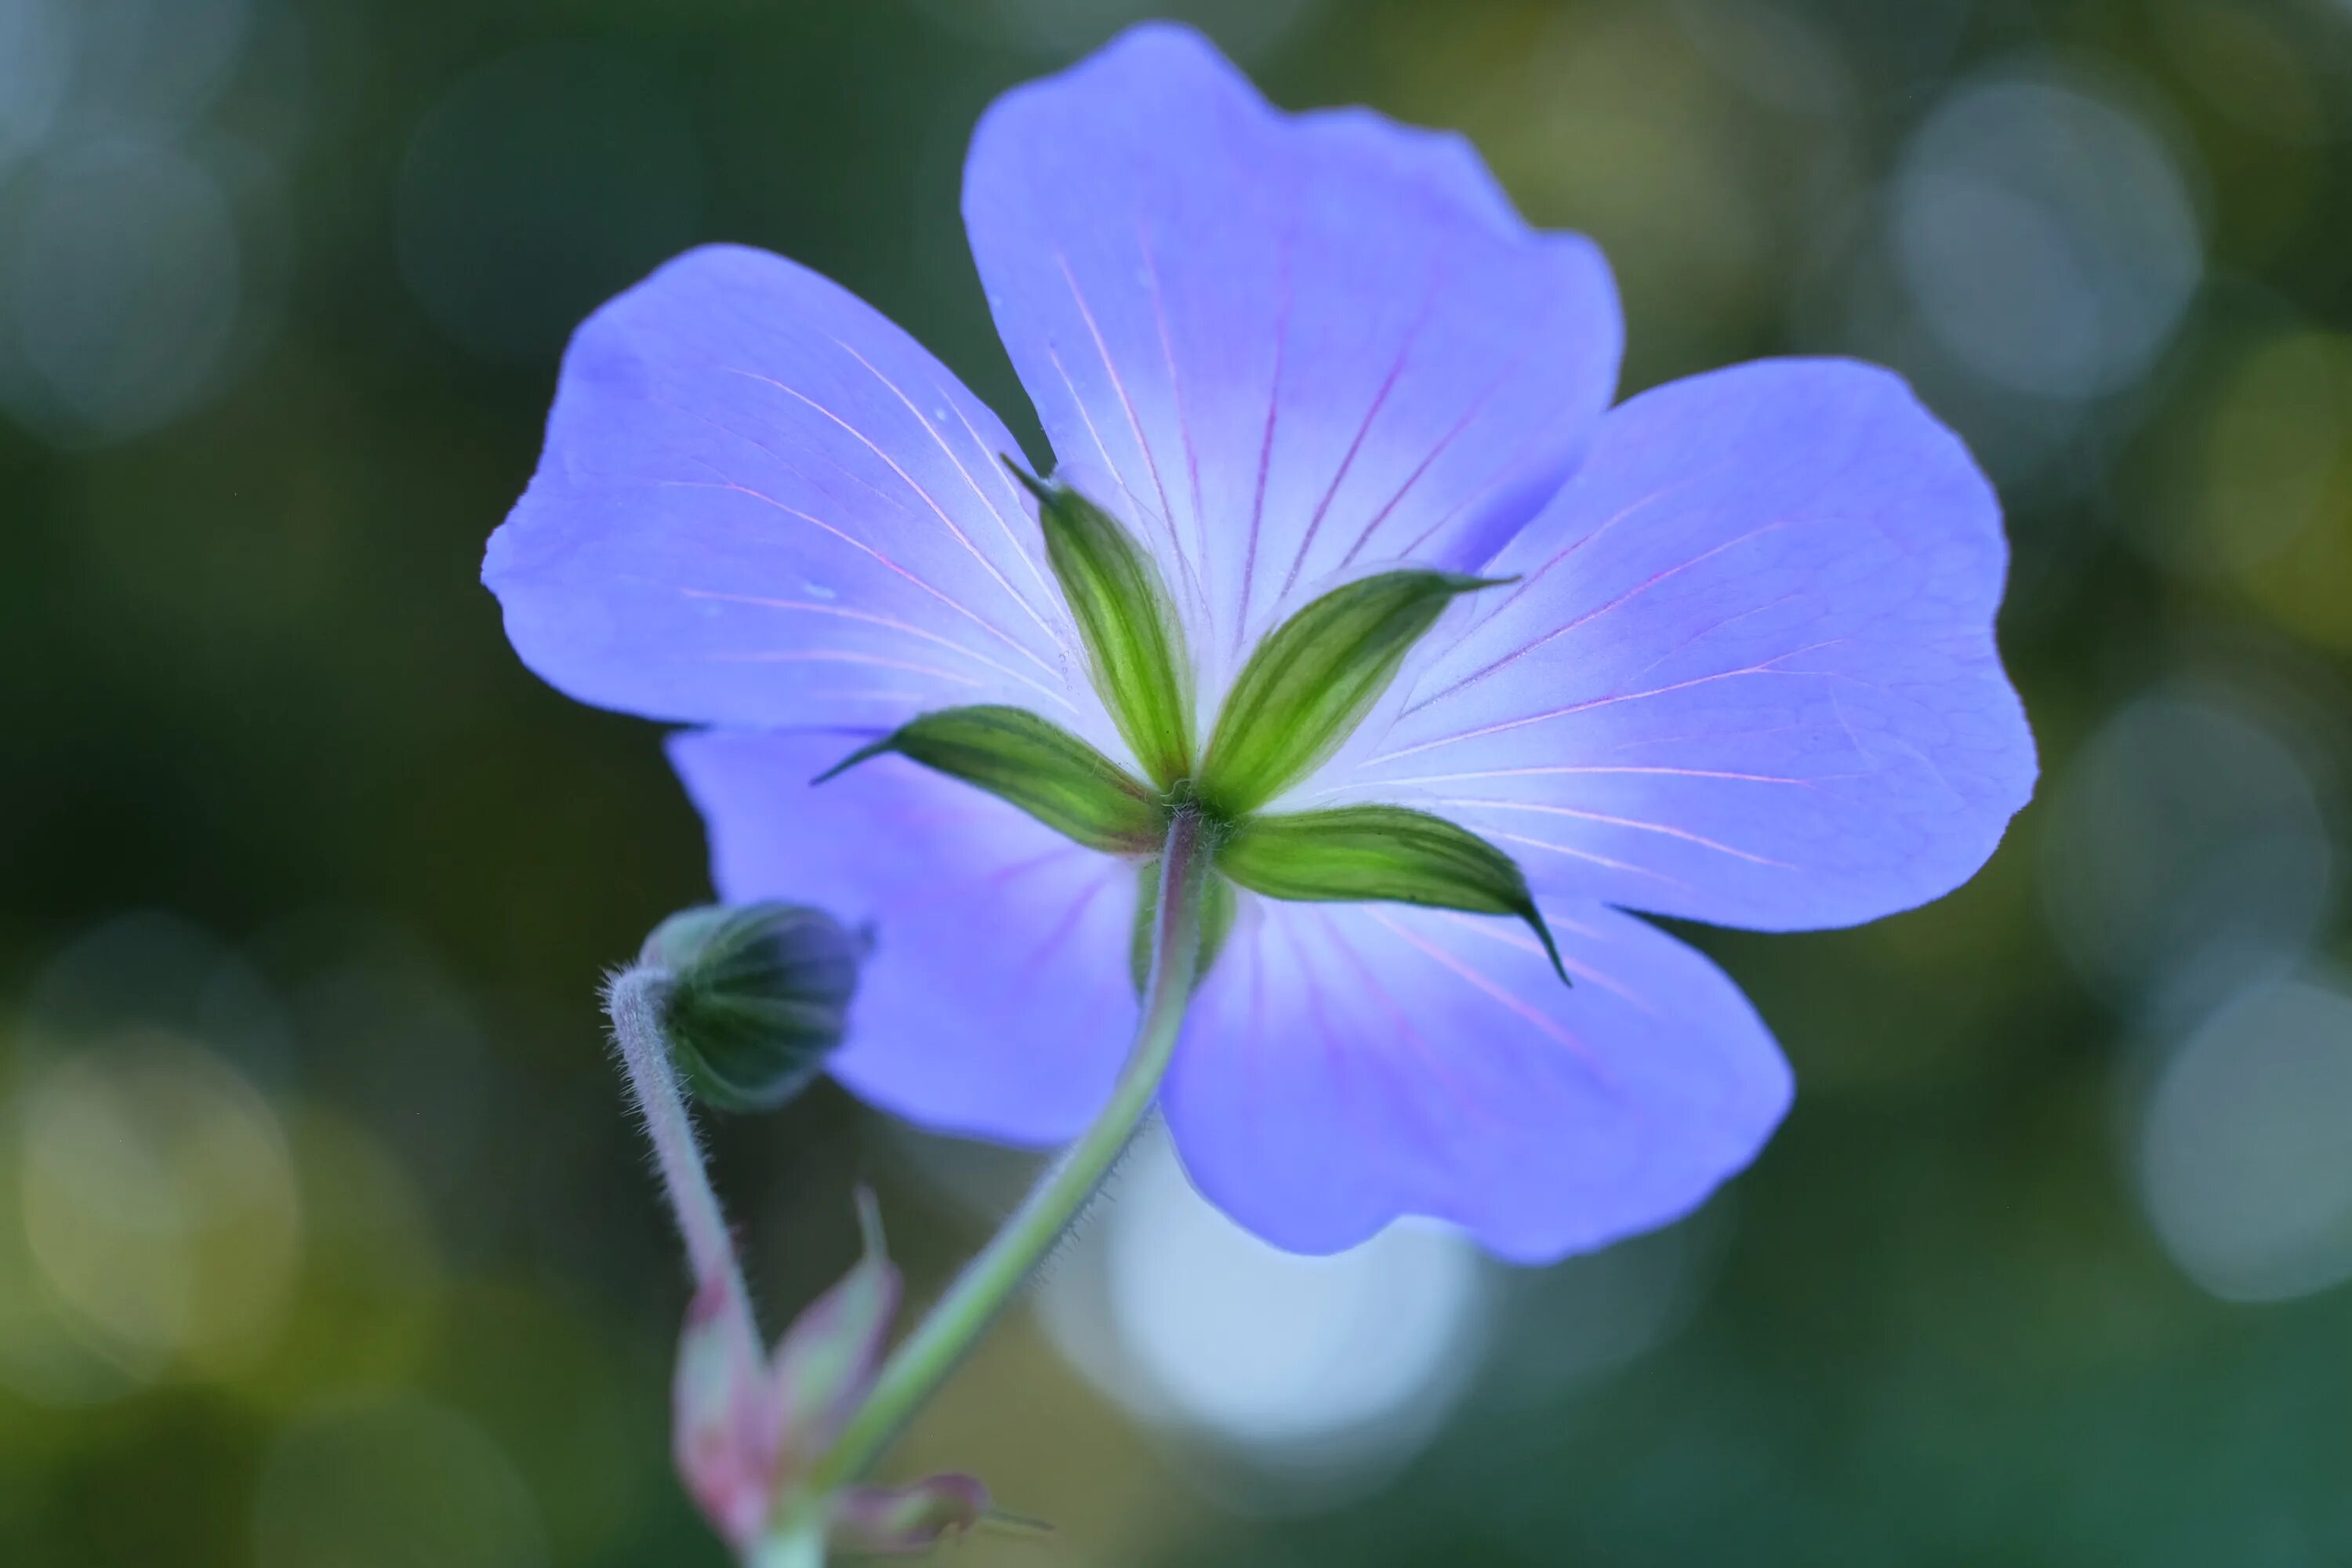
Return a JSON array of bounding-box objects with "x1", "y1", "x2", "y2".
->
[{"x1": 816, "y1": 480, "x2": 1569, "y2": 989}]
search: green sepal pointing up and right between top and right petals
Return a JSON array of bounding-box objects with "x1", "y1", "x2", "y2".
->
[{"x1": 1200, "y1": 572, "x2": 1510, "y2": 818}]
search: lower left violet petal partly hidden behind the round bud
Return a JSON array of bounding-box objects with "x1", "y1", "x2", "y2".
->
[{"x1": 670, "y1": 731, "x2": 1136, "y2": 1142}]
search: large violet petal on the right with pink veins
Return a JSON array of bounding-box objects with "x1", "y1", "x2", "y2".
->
[{"x1": 1345, "y1": 360, "x2": 2034, "y2": 931}]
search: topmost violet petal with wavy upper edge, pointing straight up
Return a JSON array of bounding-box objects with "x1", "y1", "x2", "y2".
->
[{"x1": 964, "y1": 24, "x2": 1623, "y2": 699}]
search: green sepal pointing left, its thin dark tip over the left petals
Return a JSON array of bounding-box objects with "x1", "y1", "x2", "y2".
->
[{"x1": 816, "y1": 706, "x2": 1162, "y2": 855}]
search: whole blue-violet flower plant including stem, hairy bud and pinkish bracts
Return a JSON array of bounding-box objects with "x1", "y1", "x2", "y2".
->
[{"x1": 485, "y1": 24, "x2": 2034, "y2": 1568}]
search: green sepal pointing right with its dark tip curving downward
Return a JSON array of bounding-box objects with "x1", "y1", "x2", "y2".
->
[{"x1": 1216, "y1": 806, "x2": 1569, "y2": 982}]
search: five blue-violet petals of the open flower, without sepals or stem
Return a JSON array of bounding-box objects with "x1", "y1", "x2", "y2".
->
[{"x1": 485, "y1": 26, "x2": 2034, "y2": 1260}]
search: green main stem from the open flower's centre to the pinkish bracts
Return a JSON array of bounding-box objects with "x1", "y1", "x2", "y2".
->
[{"x1": 814, "y1": 806, "x2": 1209, "y2": 1490}]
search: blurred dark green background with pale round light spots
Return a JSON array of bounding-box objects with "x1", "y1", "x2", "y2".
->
[{"x1": 0, "y1": 0, "x2": 2352, "y2": 1568}]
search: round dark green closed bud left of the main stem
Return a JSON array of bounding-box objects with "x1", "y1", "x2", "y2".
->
[{"x1": 637, "y1": 902, "x2": 873, "y2": 1109}]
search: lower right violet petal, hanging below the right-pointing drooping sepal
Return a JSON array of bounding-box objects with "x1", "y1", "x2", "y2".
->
[{"x1": 1162, "y1": 898, "x2": 1790, "y2": 1262}]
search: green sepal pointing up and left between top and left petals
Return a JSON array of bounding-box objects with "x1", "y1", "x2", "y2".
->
[{"x1": 1004, "y1": 459, "x2": 1192, "y2": 789}]
